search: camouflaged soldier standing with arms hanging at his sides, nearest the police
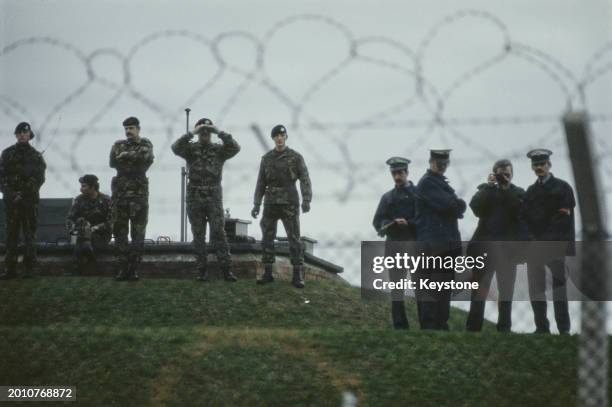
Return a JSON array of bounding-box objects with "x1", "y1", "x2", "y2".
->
[{"x1": 251, "y1": 124, "x2": 312, "y2": 288}]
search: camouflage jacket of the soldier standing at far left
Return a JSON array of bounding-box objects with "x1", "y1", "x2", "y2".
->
[{"x1": 0, "y1": 143, "x2": 47, "y2": 203}]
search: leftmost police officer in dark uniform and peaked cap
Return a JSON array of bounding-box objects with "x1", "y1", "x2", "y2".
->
[{"x1": 372, "y1": 157, "x2": 416, "y2": 329}]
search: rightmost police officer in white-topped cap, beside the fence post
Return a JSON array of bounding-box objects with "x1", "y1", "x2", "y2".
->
[{"x1": 523, "y1": 148, "x2": 576, "y2": 334}]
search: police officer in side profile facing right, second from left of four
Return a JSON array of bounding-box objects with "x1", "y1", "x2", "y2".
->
[{"x1": 414, "y1": 149, "x2": 466, "y2": 330}]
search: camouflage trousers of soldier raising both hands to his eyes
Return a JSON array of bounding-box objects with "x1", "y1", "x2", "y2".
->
[{"x1": 187, "y1": 198, "x2": 231, "y2": 269}]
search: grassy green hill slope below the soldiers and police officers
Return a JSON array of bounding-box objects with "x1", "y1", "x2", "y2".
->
[{"x1": 0, "y1": 277, "x2": 604, "y2": 406}]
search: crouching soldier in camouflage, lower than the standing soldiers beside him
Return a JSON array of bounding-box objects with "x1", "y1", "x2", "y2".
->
[{"x1": 66, "y1": 174, "x2": 112, "y2": 274}]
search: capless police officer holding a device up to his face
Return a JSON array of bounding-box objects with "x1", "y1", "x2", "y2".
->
[{"x1": 466, "y1": 159, "x2": 526, "y2": 332}]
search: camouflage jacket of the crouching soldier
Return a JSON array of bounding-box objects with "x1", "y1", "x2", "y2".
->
[{"x1": 66, "y1": 193, "x2": 112, "y2": 235}]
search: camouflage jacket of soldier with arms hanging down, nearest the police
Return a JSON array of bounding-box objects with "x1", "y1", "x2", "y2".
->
[{"x1": 254, "y1": 147, "x2": 312, "y2": 205}]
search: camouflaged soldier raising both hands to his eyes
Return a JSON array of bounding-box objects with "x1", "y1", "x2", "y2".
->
[{"x1": 172, "y1": 119, "x2": 240, "y2": 281}]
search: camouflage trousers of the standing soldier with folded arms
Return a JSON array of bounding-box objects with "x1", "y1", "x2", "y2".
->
[{"x1": 112, "y1": 199, "x2": 149, "y2": 266}]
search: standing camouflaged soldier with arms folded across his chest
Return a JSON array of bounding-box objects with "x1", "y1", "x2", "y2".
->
[{"x1": 110, "y1": 117, "x2": 154, "y2": 281}]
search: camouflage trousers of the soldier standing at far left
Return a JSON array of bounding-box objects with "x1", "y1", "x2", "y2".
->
[{"x1": 4, "y1": 199, "x2": 38, "y2": 273}]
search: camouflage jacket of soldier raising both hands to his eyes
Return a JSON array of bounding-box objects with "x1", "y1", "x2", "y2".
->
[{"x1": 172, "y1": 132, "x2": 240, "y2": 195}]
